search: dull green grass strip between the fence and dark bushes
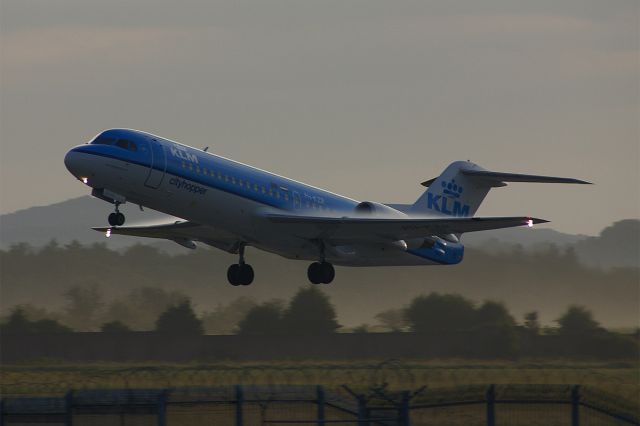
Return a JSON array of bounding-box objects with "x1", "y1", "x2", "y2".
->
[{"x1": 0, "y1": 360, "x2": 640, "y2": 400}]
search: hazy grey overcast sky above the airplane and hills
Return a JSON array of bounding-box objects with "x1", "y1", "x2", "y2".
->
[{"x1": 0, "y1": 0, "x2": 640, "y2": 234}]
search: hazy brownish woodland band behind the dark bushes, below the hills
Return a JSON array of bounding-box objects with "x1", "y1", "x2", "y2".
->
[{"x1": 0, "y1": 241, "x2": 640, "y2": 333}]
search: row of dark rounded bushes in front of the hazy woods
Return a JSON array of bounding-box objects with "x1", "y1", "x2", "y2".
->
[{"x1": 0, "y1": 287, "x2": 640, "y2": 358}]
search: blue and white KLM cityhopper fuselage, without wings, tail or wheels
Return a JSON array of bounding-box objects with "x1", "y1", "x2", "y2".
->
[{"x1": 65, "y1": 129, "x2": 463, "y2": 266}]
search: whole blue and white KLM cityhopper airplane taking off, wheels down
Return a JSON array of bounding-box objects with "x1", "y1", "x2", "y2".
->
[{"x1": 64, "y1": 129, "x2": 590, "y2": 286}]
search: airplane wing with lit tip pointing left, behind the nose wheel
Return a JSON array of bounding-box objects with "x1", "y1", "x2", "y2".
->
[{"x1": 92, "y1": 221, "x2": 239, "y2": 253}]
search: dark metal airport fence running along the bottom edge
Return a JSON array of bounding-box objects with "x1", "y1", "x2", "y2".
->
[{"x1": 0, "y1": 385, "x2": 640, "y2": 426}]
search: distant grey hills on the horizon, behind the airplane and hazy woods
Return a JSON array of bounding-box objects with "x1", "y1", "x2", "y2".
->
[{"x1": 0, "y1": 196, "x2": 640, "y2": 267}]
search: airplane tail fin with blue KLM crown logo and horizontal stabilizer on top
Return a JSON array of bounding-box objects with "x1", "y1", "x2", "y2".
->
[{"x1": 411, "y1": 161, "x2": 589, "y2": 217}]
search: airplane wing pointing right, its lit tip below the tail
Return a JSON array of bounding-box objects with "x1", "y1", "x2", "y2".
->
[{"x1": 266, "y1": 214, "x2": 548, "y2": 242}]
